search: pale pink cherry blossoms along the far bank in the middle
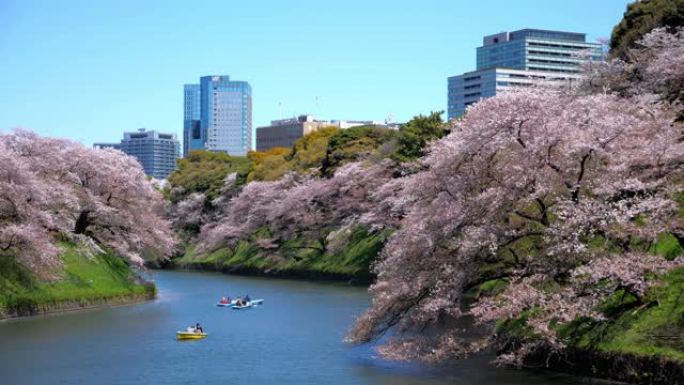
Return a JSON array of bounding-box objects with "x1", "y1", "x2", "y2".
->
[{"x1": 199, "y1": 161, "x2": 393, "y2": 258}]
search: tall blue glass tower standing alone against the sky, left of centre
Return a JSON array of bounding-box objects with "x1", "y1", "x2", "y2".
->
[{"x1": 183, "y1": 76, "x2": 254, "y2": 156}]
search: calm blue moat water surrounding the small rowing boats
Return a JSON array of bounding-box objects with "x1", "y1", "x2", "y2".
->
[{"x1": 0, "y1": 271, "x2": 604, "y2": 385}]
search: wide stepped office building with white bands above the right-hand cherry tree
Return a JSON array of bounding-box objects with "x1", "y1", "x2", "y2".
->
[{"x1": 448, "y1": 29, "x2": 602, "y2": 119}]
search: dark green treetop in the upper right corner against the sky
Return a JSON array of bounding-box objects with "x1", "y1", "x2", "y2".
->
[{"x1": 610, "y1": 0, "x2": 684, "y2": 59}]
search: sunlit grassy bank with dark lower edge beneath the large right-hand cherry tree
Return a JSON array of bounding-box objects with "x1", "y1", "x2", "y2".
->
[{"x1": 474, "y1": 233, "x2": 684, "y2": 384}]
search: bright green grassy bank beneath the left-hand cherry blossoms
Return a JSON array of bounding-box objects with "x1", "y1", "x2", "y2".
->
[{"x1": 0, "y1": 244, "x2": 156, "y2": 318}]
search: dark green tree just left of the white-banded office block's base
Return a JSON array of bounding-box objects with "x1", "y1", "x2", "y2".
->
[{"x1": 393, "y1": 111, "x2": 449, "y2": 162}]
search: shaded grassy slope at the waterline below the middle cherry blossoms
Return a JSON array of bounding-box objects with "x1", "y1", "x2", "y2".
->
[{"x1": 174, "y1": 227, "x2": 390, "y2": 283}]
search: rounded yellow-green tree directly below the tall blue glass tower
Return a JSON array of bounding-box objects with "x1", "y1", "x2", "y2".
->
[{"x1": 169, "y1": 151, "x2": 250, "y2": 199}]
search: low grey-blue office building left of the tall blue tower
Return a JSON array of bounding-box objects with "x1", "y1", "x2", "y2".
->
[{"x1": 93, "y1": 128, "x2": 180, "y2": 179}]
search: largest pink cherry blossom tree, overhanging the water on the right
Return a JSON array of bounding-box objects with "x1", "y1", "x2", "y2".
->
[{"x1": 349, "y1": 31, "x2": 684, "y2": 362}]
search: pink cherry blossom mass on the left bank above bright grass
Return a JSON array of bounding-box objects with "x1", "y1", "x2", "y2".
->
[{"x1": 0, "y1": 130, "x2": 174, "y2": 271}]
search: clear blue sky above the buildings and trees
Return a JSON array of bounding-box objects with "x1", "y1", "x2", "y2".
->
[{"x1": 0, "y1": 0, "x2": 630, "y2": 145}]
